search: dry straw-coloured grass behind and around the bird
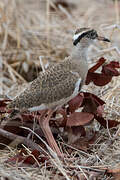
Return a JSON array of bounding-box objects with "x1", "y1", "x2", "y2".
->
[{"x1": 0, "y1": 0, "x2": 120, "y2": 180}]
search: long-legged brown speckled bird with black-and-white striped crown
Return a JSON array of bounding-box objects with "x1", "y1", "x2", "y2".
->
[{"x1": 7, "y1": 27, "x2": 110, "y2": 157}]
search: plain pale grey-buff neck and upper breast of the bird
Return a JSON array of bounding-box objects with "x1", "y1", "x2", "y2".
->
[{"x1": 71, "y1": 45, "x2": 88, "y2": 79}]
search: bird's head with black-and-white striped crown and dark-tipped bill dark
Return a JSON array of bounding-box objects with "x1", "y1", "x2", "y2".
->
[{"x1": 73, "y1": 28, "x2": 110, "y2": 47}]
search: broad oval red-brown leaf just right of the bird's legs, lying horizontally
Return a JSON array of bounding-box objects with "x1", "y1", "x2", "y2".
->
[{"x1": 67, "y1": 112, "x2": 94, "y2": 127}]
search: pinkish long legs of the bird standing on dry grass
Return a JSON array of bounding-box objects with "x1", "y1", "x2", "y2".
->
[{"x1": 39, "y1": 110, "x2": 63, "y2": 157}]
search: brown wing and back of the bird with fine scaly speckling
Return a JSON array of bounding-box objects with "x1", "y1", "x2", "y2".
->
[{"x1": 9, "y1": 59, "x2": 79, "y2": 109}]
